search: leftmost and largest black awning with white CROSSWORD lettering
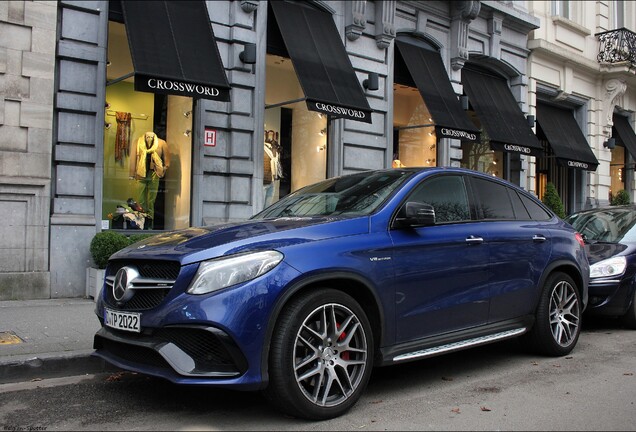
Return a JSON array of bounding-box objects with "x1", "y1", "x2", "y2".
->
[{"x1": 122, "y1": 1, "x2": 230, "y2": 101}]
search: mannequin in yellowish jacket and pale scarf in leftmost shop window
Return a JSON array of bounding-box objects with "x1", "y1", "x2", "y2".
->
[{"x1": 130, "y1": 132, "x2": 170, "y2": 229}]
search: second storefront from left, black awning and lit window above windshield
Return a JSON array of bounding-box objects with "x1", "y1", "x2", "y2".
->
[{"x1": 263, "y1": 2, "x2": 371, "y2": 207}]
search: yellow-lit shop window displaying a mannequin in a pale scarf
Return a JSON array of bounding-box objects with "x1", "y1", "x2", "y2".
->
[{"x1": 102, "y1": 21, "x2": 193, "y2": 230}]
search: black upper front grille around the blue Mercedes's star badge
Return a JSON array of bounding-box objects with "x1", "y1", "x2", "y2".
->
[{"x1": 104, "y1": 260, "x2": 181, "y2": 310}]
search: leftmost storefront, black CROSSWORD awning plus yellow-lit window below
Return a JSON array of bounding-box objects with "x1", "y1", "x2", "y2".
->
[{"x1": 101, "y1": 1, "x2": 230, "y2": 230}]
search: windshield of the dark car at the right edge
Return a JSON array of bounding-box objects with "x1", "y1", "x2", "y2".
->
[{"x1": 565, "y1": 207, "x2": 636, "y2": 243}]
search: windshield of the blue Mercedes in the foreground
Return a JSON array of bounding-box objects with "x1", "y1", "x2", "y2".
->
[{"x1": 252, "y1": 170, "x2": 412, "y2": 219}]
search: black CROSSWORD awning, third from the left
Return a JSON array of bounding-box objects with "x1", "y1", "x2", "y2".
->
[{"x1": 395, "y1": 40, "x2": 480, "y2": 142}]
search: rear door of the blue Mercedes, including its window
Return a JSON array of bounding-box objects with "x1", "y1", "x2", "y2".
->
[{"x1": 471, "y1": 177, "x2": 552, "y2": 323}]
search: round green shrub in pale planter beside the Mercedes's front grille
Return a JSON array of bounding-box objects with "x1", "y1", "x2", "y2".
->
[{"x1": 86, "y1": 231, "x2": 130, "y2": 299}]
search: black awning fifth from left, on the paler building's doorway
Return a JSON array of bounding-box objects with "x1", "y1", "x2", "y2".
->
[{"x1": 537, "y1": 104, "x2": 598, "y2": 171}]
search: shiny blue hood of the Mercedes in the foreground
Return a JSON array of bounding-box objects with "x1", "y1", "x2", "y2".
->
[{"x1": 111, "y1": 217, "x2": 369, "y2": 265}]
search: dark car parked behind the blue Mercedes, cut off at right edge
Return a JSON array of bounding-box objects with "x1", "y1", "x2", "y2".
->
[{"x1": 566, "y1": 205, "x2": 636, "y2": 329}]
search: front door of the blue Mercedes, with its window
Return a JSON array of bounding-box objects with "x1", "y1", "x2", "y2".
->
[{"x1": 390, "y1": 174, "x2": 489, "y2": 343}]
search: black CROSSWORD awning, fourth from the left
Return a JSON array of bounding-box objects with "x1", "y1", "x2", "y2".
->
[{"x1": 462, "y1": 67, "x2": 543, "y2": 156}]
